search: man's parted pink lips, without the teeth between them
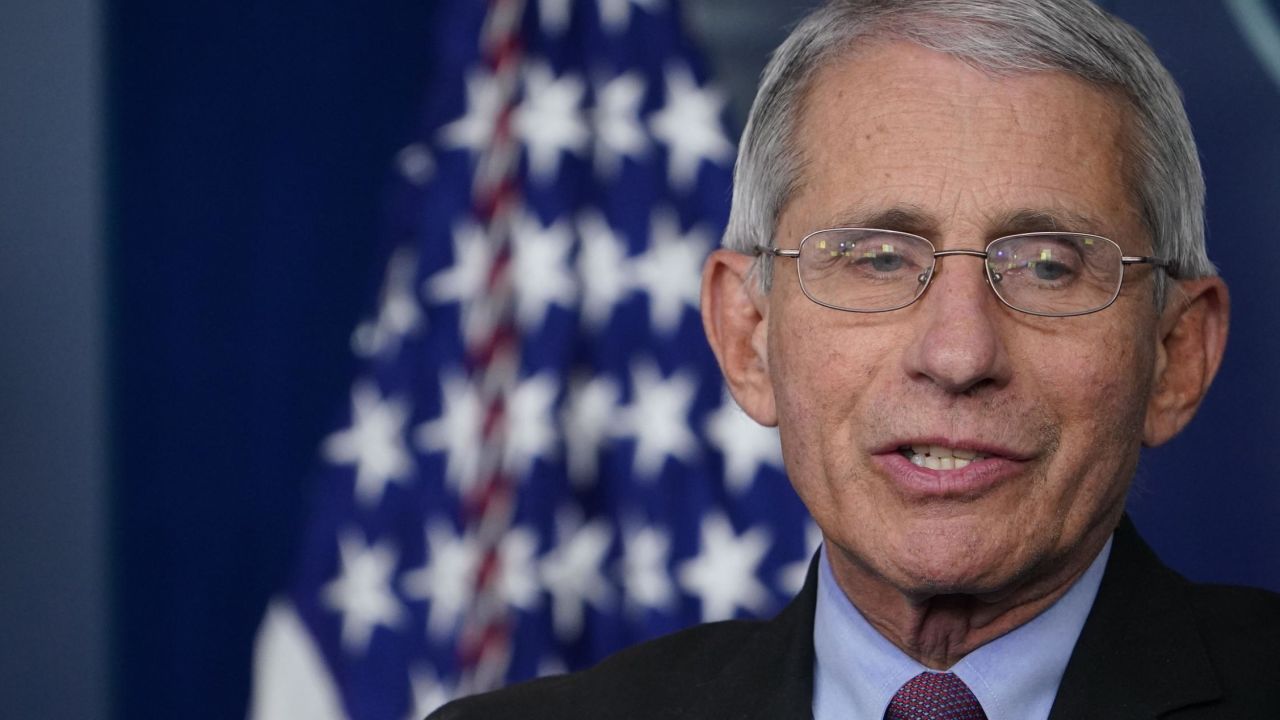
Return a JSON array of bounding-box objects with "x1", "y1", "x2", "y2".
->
[{"x1": 872, "y1": 439, "x2": 1030, "y2": 501}]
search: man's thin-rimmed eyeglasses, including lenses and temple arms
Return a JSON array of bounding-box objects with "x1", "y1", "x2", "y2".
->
[{"x1": 755, "y1": 228, "x2": 1169, "y2": 318}]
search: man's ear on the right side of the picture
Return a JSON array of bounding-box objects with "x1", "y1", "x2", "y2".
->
[{"x1": 1142, "y1": 278, "x2": 1231, "y2": 447}]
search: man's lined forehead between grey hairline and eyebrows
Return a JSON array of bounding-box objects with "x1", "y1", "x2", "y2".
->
[{"x1": 780, "y1": 42, "x2": 1140, "y2": 241}]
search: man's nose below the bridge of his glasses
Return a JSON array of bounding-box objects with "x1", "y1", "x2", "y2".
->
[{"x1": 904, "y1": 255, "x2": 1010, "y2": 395}]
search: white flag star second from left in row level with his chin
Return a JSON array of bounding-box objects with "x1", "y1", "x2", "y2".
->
[{"x1": 401, "y1": 520, "x2": 479, "y2": 639}]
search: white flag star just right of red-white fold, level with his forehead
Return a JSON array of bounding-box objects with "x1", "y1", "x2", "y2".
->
[{"x1": 513, "y1": 63, "x2": 591, "y2": 182}]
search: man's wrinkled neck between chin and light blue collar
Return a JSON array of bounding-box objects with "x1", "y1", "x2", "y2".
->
[{"x1": 828, "y1": 537, "x2": 1106, "y2": 670}]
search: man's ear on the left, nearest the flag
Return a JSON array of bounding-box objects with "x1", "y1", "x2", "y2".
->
[{"x1": 701, "y1": 250, "x2": 778, "y2": 427}]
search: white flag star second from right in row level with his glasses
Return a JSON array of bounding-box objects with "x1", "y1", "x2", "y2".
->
[{"x1": 577, "y1": 210, "x2": 631, "y2": 331}]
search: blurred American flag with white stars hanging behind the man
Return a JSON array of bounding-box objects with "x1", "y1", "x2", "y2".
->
[{"x1": 250, "y1": 0, "x2": 817, "y2": 720}]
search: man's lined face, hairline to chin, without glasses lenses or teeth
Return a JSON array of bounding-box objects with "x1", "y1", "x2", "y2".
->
[{"x1": 763, "y1": 44, "x2": 1157, "y2": 597}]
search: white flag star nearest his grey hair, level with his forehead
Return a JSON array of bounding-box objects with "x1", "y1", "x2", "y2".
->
[{"x1": 649, "y1": 65, "x2": 733, "y2": 190}]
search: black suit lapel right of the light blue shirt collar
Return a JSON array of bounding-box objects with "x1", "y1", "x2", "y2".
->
[{"x1": 1050, "y1": 516, "x2": 1222, "y2": 720}]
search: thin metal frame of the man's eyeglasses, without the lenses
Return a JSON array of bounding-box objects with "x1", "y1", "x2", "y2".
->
[{"x1": 754, "y1": 228, "x2": 1171, "y2": 318}]
